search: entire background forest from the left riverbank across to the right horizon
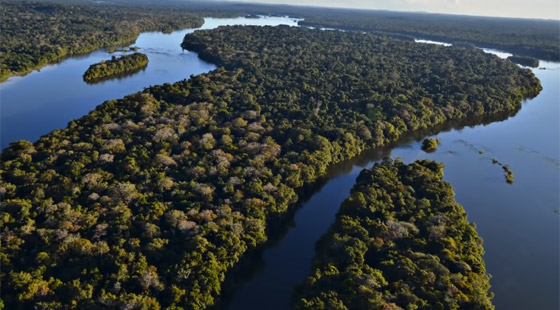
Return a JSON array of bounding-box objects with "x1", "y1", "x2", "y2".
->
[{"x1": 0, "y1": 0, "x2": 560, "y2": 81}]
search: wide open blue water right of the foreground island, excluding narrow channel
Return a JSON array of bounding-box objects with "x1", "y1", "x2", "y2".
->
[{"x1": 392, "y1": 60, "x2": 560, "y2": 310}]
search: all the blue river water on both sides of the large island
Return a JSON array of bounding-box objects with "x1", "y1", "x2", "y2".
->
[{"x1": 0, "y1": 17, "x2": 560, "y2": 310}]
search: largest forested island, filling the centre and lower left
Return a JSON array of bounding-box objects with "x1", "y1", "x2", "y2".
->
[{"x1": 0, "y1": 27, "x2": 541, "y2": 310}]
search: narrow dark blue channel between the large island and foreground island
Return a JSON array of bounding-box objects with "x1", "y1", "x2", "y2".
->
[{"x1": 222, "y1": 149, "x2": 390, "y2": 310}]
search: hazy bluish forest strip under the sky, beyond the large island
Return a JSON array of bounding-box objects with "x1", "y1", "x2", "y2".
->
[{"x1": 118, "y1": 0, "x2": 560, "y2": 61}]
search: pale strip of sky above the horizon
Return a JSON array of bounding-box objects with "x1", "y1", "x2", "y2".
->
[{"x1": 228, "y1": 0, "x2": 560, "y2": 19}]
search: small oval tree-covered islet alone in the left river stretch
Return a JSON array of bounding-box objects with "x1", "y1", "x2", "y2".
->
[{"x1": 83, "y1": 53, "x2": 148, "y2": 83}]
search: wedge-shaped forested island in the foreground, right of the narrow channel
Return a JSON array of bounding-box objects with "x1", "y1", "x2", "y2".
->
[{"x1": 293, "y1": 160, "x2": 494, "y2": 310}]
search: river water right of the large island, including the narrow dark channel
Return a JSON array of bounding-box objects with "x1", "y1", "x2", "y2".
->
[{"x1": 222, "y1": 59, "x2": 560, "y2": 310}]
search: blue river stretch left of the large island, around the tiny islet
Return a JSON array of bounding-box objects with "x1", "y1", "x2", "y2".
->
[{"x1": 0, "y1": 17, "x2": 297, "y2": 149}]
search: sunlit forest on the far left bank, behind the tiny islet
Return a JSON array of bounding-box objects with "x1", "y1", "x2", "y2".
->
[{"x1": 0, "y1": 0, "x2": 204, "y2": 81}]
